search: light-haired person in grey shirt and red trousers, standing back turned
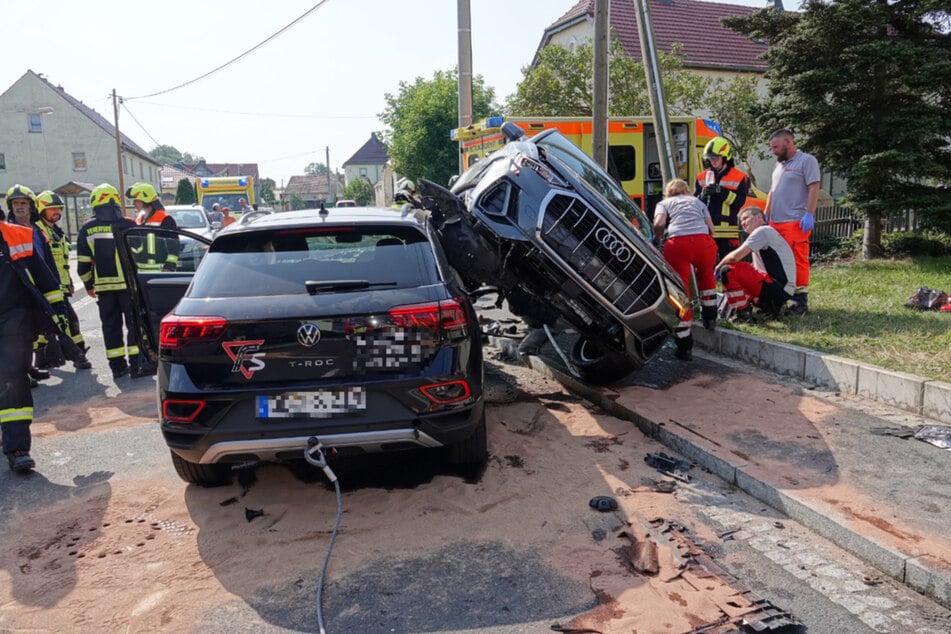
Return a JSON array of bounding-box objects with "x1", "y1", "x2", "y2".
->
[{"x1": 654, "y1": 178, "x2": 717, "y2": 361}]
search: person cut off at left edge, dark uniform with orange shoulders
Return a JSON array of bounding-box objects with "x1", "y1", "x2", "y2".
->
[{"x1": 0, "y1": 201, "x2": 66, "y2": 473}]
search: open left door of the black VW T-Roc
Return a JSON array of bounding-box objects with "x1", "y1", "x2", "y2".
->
[{"x1": 116, "y1": 225, "x2": 211, "y2": 363}]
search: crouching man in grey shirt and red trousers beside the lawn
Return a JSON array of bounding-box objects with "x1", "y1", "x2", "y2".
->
[{"x1": 716, "y1": 207, "x2": 796, "y2": 322}]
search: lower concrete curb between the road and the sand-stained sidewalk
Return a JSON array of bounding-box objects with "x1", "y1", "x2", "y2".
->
[{"x1": 529, "y1": 354, "x2": 951, "y2": 608}]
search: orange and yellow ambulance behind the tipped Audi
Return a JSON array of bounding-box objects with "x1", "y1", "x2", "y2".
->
[{"x1": 451, "y1": 116, "x2": 766, "y2": 218}]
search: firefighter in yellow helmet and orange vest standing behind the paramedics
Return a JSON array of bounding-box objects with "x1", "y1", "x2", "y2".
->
[{"x1": 694, "y1": 136, "x2": 750, "y2": 259}]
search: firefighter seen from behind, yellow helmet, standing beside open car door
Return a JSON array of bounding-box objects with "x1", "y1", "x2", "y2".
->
[{"x1": 76, "y1": 183, "x2": 151, "y2": 379}]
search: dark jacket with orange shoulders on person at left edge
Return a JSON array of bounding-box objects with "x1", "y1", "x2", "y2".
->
[{"x1": 0, "y1": 221, "x2": 65, "y2": 326}]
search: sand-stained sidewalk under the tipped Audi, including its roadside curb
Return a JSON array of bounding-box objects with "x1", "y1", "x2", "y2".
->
[{"x1": 494, "y1": 316, "x2": 951, "y2": 607}]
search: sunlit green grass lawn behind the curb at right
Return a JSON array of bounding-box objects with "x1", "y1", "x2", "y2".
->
[{"x1": 724, "y1": 257, "x2": 951, "y2": 383}]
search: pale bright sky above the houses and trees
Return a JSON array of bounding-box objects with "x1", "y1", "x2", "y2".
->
[{"x1": 0, "y1": 0, "x2": 769, "y2": 185}]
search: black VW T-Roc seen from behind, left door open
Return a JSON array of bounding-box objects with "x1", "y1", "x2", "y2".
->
[{"x1": 117, "y1": 208, "x2": 487, "y2": 486}]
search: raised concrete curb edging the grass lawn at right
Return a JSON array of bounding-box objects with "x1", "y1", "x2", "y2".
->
[{"x1": 693, "y1": 328, "x2": 951, "y2": 425}]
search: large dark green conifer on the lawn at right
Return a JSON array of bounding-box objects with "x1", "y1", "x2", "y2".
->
[{"x1": 724, "y1": 0, "x2": 951, "y2": 258}]
